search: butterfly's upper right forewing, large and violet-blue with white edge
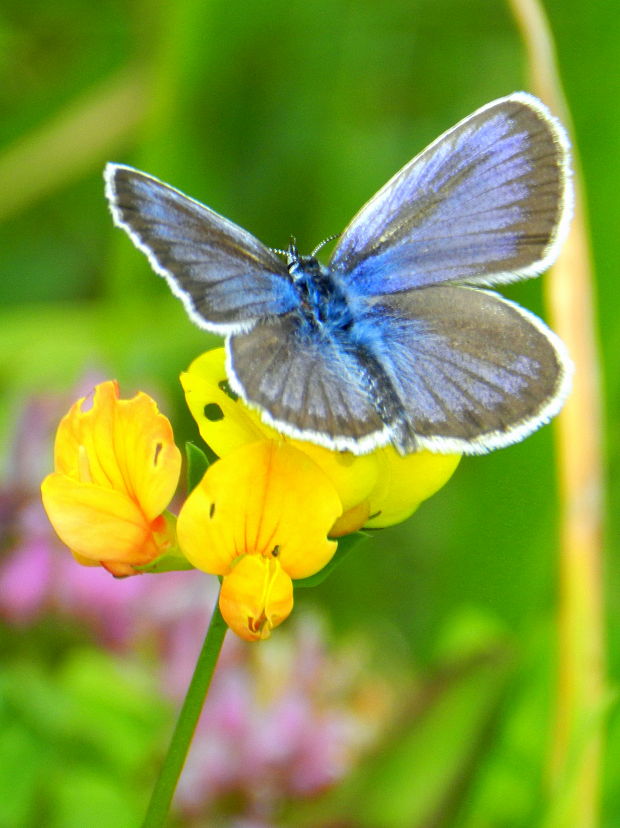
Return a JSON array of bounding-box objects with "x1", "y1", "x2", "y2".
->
[{"x1": 331, "y1": 92, "x2": 572, "y2": 296}]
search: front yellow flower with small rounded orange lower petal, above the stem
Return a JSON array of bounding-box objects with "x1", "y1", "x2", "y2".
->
[{"x1": 177, "y1": 439, "x2": 342, "y2": 641}]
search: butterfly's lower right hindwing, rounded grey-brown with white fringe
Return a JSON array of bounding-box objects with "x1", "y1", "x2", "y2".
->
[{"x1": 357, "y1": 285, "x2": 572, "y2": 454}]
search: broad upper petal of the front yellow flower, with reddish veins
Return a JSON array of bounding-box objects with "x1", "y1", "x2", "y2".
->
[{"x1": 177, "y1": 440, "x2": 342, "y2": 578}]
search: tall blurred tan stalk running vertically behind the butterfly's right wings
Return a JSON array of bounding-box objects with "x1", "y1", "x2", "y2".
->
[{"x1": 510, "y1": 0, "x2": 605, "y2": 828}]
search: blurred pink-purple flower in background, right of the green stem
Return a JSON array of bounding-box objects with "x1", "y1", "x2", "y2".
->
[{"x1": 176, "y1": 615, "x2": 394, "y2": 825}]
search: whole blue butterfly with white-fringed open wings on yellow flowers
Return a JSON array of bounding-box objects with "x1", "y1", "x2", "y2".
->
[{"x1": 105, "y1": 92, "x2": 572, "y2": 454}]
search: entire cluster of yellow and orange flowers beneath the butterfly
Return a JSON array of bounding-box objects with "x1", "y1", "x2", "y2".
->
[{"x1": 36, "y1": 349, "x2": 459, "y2": 641}]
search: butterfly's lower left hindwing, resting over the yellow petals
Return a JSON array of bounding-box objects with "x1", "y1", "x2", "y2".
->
[{"x1": 226, "y1": 313, "x2": 391, "y2": 454}]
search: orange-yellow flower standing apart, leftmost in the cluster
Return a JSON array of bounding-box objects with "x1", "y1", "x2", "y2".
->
[{"x1": 41, "y1": 382, "x2": 181, "y2": 575}]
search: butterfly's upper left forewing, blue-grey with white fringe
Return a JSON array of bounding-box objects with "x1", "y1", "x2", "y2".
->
[{"x1": 105, "y1": 164, "x2": 297, "y2": 334}]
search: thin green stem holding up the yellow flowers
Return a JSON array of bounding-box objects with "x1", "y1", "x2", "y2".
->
[{"x1": 142, "y1": 604, "x2": 228, "y2": 828}]
